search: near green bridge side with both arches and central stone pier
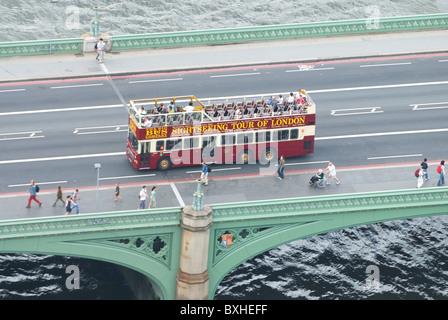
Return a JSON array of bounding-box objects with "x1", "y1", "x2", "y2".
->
[{"x1": 0, "y1": 187, "x2": 448, "y2": 300}]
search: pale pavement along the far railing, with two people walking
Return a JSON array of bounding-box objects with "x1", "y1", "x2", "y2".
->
[{"x1": 0, "y1": 30, "x2": 448, "y2": 83}]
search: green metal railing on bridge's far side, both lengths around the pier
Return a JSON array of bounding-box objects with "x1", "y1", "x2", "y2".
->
[{"x1": 0, "y1": 13, "x2": 448, "y2": 57}]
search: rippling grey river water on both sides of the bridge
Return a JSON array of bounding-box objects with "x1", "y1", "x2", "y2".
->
[{"x1": 0, "y1": 0, "x2": 448, "y2": 300}]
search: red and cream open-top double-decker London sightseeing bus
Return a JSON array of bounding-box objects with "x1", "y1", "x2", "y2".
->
[{"x1": 126, "y1": 90, "x2": 316, "y2": 170}]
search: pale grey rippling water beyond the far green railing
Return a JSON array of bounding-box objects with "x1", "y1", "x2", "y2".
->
[{"x1": 0, "y1": 0, "x2": 448, "y2": 42}]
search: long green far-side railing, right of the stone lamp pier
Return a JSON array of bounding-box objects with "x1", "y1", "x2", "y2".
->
[{"x1": 112, "y1": 14, "x2": 448, "y2": 50}]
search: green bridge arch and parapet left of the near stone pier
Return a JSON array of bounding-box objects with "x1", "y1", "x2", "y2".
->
[{"x1": 0, "y1": 208, "x2": 181, "y2": 300}]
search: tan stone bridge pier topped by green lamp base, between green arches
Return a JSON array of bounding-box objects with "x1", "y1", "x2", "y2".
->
[{"x1": 175, "y1": 180, "x2": 213, "y2": 300}]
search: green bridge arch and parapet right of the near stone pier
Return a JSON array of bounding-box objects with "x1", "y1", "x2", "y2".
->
[{"x1": 208, "y1": 187, "x2": 448, "y2": 299}]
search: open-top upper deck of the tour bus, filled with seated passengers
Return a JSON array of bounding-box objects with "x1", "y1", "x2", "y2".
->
[{"x1": 129, "y1": 90, "x2": 316, "y2": 134}]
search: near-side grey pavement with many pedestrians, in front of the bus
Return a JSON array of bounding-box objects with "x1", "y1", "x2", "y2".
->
[{"x1": 0, "y1": 160, "x2": 446, "y2": 220}]
